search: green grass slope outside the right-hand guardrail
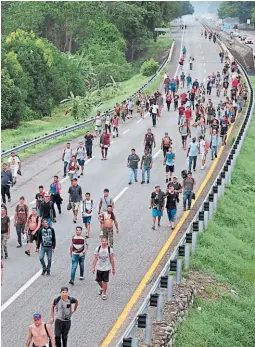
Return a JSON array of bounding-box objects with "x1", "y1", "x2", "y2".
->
[{"x1": 174, "y1": 78, "x2": 255, "y2": 347}]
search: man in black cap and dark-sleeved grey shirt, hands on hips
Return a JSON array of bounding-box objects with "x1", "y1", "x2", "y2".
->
[{"x1": 50, "y1": 287, "x2": 79, "y2": 347}]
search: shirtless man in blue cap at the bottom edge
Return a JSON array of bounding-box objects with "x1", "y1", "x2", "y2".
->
[{"x1": 26, "y1": 313, "x2": 55, "y2": 347}]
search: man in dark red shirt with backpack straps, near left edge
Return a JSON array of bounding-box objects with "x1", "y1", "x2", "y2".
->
[{"x1": 14, "y1": 196, "x2": 29, "y2": 248}]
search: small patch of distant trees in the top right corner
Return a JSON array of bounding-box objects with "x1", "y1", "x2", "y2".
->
[{"x1": 218, "y1": 1, "x2": 255, "y2": 23}]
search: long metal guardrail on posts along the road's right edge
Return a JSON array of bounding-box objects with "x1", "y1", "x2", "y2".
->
[{"x1": 116, "y1": 30, "x2": 254, "y2": 347}]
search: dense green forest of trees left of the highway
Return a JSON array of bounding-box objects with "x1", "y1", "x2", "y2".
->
[{"x1": 1, "y1": 1, "x2": 193, "y2": 129}]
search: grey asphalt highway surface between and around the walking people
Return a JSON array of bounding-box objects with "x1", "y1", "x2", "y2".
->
[{"x1": 1, "y1": 16, "x2": 225, "y2": 347}]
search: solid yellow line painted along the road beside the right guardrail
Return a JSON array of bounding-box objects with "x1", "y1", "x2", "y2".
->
[{"x1": 101, "y1": 123, "x2": 234, "y2": 347}]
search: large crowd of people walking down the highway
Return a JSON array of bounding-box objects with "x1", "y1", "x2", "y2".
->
[{"x1": 1, "y1": 30, "x2": 247, "y2": 347}]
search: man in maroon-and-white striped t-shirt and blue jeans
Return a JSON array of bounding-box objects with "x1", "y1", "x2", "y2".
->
[{"x1": 69, "y1": 226, "x2": 88, "y2": 285}]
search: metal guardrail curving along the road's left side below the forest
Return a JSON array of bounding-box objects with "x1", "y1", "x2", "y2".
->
[{"x1": 1, "y1": 40, "x2": 174, "y2": 158}]
